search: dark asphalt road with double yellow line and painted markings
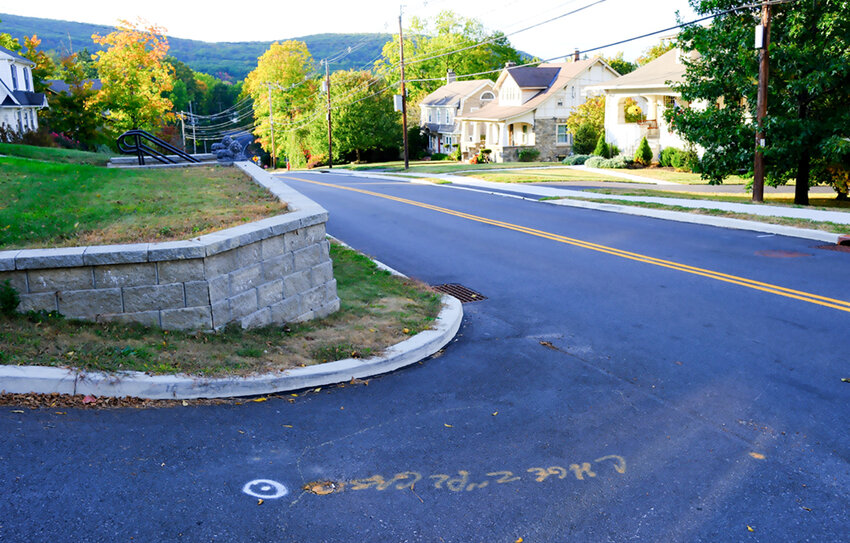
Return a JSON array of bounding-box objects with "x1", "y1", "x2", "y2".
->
[{"x1": 0, "y1": 173, "x2": 850, "y2": 543}]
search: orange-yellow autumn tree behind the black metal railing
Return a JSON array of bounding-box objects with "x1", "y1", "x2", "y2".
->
[{"x1": 87, "y1": 20, "x2": 174, "y2": 130}]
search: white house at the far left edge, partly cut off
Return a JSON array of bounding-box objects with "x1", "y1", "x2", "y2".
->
[{"x1": 0, "y1": 47, "x2": 47, "y2": 134}]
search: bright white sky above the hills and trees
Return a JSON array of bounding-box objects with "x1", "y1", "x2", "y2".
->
[{"x1": 0, "y1": 0, "x2": 696, "y2": 60}]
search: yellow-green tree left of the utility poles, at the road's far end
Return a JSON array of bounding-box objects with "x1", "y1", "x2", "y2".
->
[{"x1": 242, "y1": 40, "x2": 317, "y2": 163}]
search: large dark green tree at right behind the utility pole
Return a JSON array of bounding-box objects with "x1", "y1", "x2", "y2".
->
[{"x1": 665, "y1": 0, "x2": 850, "y2": 205}]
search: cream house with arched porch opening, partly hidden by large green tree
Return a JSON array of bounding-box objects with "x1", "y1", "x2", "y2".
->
[{"x1": 589, "y1": 49, "x2": 688, "y2": 159}]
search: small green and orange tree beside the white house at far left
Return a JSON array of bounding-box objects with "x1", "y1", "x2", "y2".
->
[{"x1": 44, "y1": 53, "x2": 104, "y2": 149}]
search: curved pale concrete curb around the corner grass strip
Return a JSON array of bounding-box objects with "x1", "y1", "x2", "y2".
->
[{"x1": 0, "y1": 296, "x2": 463, "y2": 400}]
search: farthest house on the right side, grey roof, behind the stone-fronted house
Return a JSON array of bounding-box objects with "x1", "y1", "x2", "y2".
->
[{"x1": 419, "y1": 70, "x2": 496, "y2": 154}]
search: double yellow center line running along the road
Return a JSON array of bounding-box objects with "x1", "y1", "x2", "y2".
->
[{"x1": 287, "y1": 177, "x2": 850, "y2": 313}]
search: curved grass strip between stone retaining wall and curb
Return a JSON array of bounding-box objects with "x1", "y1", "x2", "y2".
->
[{"x1": 0, "y1": 244, "x2": 441, "y2": 376}]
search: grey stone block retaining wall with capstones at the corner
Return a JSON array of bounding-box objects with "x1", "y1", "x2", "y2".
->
[{"x1": 0, "y1": 162, "x2": 339, "y2": 330}]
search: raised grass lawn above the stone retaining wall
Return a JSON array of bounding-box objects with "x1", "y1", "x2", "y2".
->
[{"x1": 0, "y1": 156, "x2": 286, "y2": 249}]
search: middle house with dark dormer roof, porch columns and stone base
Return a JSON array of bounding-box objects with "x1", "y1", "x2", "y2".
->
[{"x1": 459, "y1": 58, "x2": 620, "y2": 162}]
